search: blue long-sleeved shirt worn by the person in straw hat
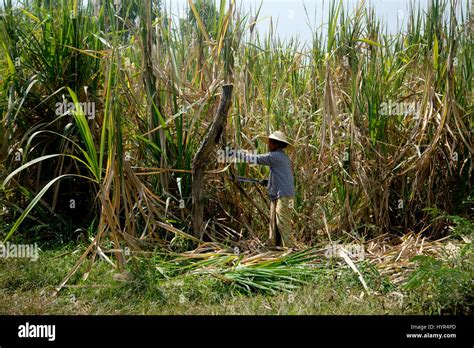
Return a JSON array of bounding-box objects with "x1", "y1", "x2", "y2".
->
[{"x1": 245, "y1": 149, "x2": 295, "y2": 201}]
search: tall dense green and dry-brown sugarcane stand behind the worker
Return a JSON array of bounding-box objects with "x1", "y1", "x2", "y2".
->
[{"x1": 0, "y1": 0, "x2": 473, "y2": 267}]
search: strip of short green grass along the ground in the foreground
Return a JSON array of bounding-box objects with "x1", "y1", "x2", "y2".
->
[{"x1": 0, "y1": 243, "x2": 472, "y2": 315}]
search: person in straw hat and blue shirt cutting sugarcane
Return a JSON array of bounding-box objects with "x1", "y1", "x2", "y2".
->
[{"x1": 241, "y1": 131, "x2": 295, "y2": 248}]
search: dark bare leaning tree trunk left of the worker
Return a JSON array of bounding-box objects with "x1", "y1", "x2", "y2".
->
[{"x1": 191, "y1": 85, "x2": 233, "y2": 239}]
